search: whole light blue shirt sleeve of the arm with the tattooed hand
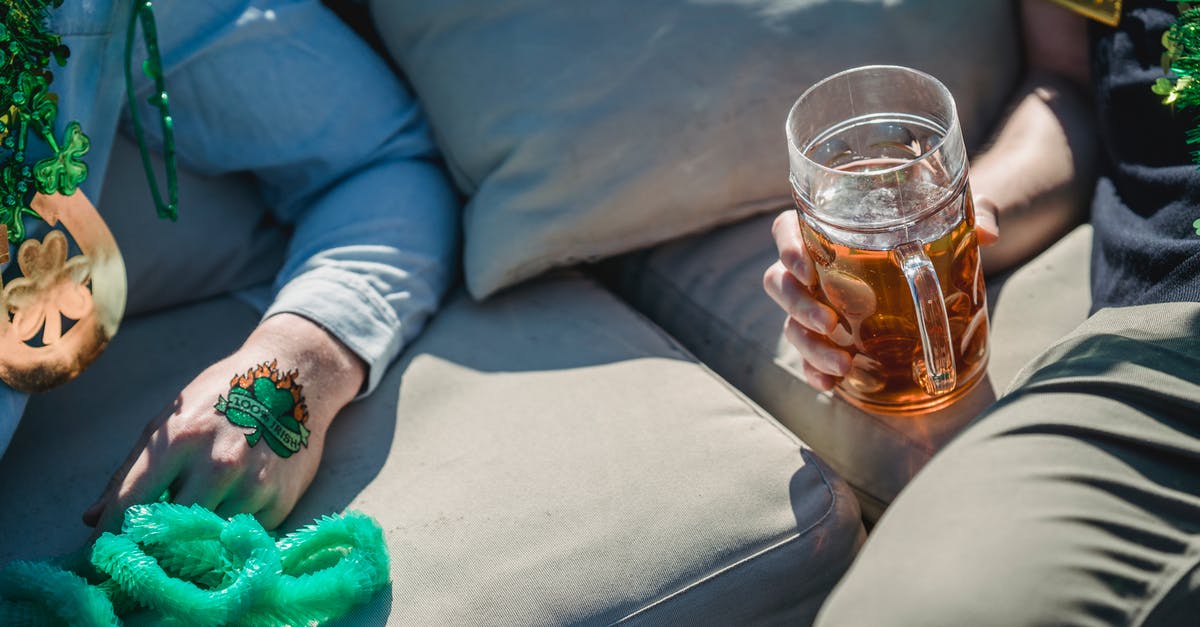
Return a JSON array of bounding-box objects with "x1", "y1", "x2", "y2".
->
[{"x1": 124, "y1": 0, "x2": 458, "y2": 392}]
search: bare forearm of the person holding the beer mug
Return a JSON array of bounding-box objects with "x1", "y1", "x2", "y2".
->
[{"x1": 971, "y1": 71, "x2": 1097, "y2": 273}]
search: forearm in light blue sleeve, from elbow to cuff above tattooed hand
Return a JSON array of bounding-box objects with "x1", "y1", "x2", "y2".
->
[{"x1": 268, "y1": 159, "x2": 458, "y2": 393}]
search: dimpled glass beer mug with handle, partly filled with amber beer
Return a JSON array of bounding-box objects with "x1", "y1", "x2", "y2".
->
[{"x1": 787, "y1": 66, "x2": 988, "y2": 414}]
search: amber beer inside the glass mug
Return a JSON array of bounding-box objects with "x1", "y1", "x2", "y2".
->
[{"x1": 797, "y1": 166, "x2": 988, "y2": 413}]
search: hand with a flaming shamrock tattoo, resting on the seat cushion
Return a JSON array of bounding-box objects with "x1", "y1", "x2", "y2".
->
[{"x1": 84, "y1": 314, "x2": 365, "y2": 531}]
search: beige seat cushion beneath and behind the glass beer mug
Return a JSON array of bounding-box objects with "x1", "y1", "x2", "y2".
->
[{"x1": 610, "y1": 215, "x2": 1091, "y2": 519}]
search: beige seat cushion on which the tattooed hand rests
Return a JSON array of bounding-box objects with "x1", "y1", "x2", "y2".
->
[{"x1": 0, "y1": 271, "x2": 863, "y2": 626}]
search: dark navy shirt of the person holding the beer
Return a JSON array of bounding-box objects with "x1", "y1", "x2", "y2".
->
[{"x1": 1092, "y1": 0, "x2": 1200, "y2": 311}]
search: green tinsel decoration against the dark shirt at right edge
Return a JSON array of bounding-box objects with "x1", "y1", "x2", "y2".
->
[{"x1": 1151, "y1": 0, "x2": 1200, "y2": 235}]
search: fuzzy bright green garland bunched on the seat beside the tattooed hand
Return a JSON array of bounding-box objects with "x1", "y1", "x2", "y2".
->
[{"x1": 0, "y1": 503, "x2": 390, "y2": 627}]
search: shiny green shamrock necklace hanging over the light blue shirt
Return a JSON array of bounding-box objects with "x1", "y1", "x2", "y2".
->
[{"x1": 0, "y1": 0, "x2": 179, "y2": 244}]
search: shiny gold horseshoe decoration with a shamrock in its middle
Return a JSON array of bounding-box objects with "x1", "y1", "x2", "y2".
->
[{"x1": 0, "y1": 191, "x2": 126, "y2": 392}]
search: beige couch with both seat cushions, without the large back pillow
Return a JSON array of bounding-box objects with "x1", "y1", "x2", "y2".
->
[{"x1": 0, "y1": 2, "x2": 1091, "y2": 625}]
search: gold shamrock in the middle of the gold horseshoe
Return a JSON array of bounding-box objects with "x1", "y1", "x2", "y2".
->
[{"x1": 4, "y1": 231, "x2": 91, "y2": 346}]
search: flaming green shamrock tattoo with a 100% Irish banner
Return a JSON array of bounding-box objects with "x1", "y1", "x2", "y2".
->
[{"x1": 214, "y1": 362, "x2": 310, "y2": 458}]
